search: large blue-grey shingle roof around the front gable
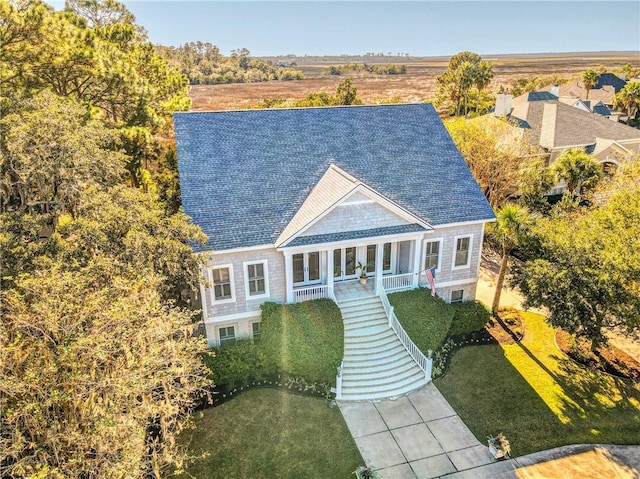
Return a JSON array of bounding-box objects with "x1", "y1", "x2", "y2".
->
[{"x1": 174, "y1": 104, "x2": 494, "y2": 250}]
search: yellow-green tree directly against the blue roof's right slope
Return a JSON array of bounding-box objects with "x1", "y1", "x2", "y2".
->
[{"x1": 445, "y1": 115, "x2": 538, "y2": 208}]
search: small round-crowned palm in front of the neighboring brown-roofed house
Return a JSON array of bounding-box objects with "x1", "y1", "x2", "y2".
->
[{"x1": 553, "y1": 148, "x2": 602, "y2": 197}]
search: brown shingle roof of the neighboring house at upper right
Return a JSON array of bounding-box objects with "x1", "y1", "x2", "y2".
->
[{"x1": 511, "y1": 101, "x2": 640, "y2": 148}]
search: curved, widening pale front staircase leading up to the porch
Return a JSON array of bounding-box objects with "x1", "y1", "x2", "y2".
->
[{"x1": 338, "y1": 296, "x2": 427, "y2": 401}]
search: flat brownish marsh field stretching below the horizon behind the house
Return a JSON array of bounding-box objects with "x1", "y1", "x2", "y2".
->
[{"x1": 190, "y1": 52, "x2": 640, "y2": 111}]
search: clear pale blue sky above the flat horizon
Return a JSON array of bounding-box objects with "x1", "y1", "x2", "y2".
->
[{"x1": 51, "y1": 0, "x2": 640, "y2": 56}]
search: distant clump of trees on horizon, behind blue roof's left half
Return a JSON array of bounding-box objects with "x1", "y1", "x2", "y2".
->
[{"x1": 156, "y1": 42, "x2": 304, "y2": 85}]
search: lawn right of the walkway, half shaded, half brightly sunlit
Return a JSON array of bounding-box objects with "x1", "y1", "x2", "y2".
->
[{"x1": 435, "y1": 313, "x2": 640, "y2": 455}]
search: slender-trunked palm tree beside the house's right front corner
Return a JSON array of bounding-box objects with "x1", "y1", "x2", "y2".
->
[{"x1": 491, "y1": 204, "x2": 535, "y2": 315}]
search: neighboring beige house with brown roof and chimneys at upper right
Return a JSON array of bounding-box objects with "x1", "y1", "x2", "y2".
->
[{"x1": 494, "y1": 92, "x2": 640, "y2": 194}]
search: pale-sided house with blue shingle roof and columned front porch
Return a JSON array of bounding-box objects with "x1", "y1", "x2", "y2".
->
[{"x1": 174, "y1": 104, "x2": 494, "y2": 344}]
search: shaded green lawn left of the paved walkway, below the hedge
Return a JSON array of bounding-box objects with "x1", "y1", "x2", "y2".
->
[{"x1": 180, "y1": 389, "x2": 364, "y2": 479}]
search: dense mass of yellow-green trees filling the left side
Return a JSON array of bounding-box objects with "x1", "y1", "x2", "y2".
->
[{"x1": 0, "y1": 0, "x2": 210, "y2": 479}]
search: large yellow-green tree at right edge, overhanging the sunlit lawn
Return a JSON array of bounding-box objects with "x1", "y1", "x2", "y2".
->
[{"x1": 513, "y1": 180, "x2": 640, "y2": 350}]
